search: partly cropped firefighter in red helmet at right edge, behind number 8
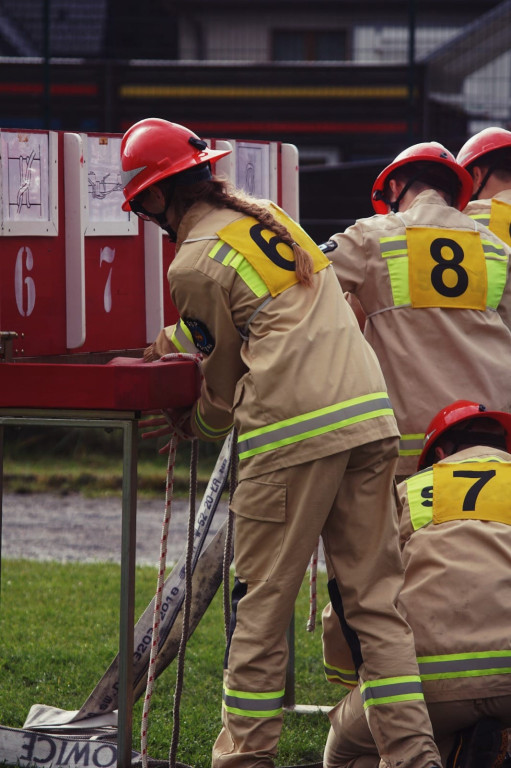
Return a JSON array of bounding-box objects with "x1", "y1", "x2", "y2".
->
[{"x1": 456, "y1": 127, "x2": 511, "y2": 246}]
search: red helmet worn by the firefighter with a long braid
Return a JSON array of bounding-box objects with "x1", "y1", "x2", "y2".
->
[{"x1": 121, "y1": 117, "x2": 231, "y2": 211}]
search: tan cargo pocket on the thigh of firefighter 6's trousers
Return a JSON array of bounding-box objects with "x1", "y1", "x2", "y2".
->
[{"x1": 231, "y1": 480, "x2": 287, "y2": 581}]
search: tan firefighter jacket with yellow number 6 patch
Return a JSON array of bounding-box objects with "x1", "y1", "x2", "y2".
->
[{"x1": 153, "y1": 203, "x2": 398, "y2": 478}]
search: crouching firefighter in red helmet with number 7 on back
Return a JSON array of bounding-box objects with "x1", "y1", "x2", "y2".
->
[{"x1": 323, "y1": 400, "x2": 511, "y2": 768}]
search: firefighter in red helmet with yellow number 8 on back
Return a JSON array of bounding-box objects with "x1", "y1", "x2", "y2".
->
[{"x1": 321, "y1": 142, "x2": 511, "y2": 479}]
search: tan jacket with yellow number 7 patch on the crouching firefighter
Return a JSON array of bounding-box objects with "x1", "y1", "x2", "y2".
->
[{"x1": 323, "y1": 446, "x2": 511, "y2": 701}]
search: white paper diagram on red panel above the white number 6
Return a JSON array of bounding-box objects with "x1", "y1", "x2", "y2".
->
[{"x1": 1, "y1": 132, "x2": 50, "y2": 222}]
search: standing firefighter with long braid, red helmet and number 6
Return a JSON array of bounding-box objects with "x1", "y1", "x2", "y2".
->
[{"x1": 121, "y1": 119, "x2": 439, "y2": 768}]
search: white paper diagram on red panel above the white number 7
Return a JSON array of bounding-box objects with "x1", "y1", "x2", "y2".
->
[{"x1": 87, "y1": 136, "x2": 129, "y2": 223}]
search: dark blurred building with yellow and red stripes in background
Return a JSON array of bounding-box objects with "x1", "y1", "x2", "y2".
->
[{"x1": 0, "y1": 0, "x2": 511, "y2": 234}]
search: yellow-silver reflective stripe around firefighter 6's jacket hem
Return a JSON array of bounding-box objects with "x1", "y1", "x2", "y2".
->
[{"x1": 238, "y1": 396, "x2": 392, "y2": 458}]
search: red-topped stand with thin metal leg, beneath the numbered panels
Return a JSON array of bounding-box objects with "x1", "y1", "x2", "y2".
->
[{"x1": 0, "y1": 354, "x2": 199, "y2": 768}]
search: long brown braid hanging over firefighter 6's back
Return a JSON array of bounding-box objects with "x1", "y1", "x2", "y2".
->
[{"x1": 168, "y1": 176, "x2": 314, "y2": 288}]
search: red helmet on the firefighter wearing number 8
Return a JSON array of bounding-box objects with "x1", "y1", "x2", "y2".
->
[{"x1": 371, "y1": 141, "x2": 473, "y2": 213}]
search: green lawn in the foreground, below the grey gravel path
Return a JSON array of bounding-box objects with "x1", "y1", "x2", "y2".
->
[{"x1": 0, "y1": 560, "x2": 344, "y2": 768}]
